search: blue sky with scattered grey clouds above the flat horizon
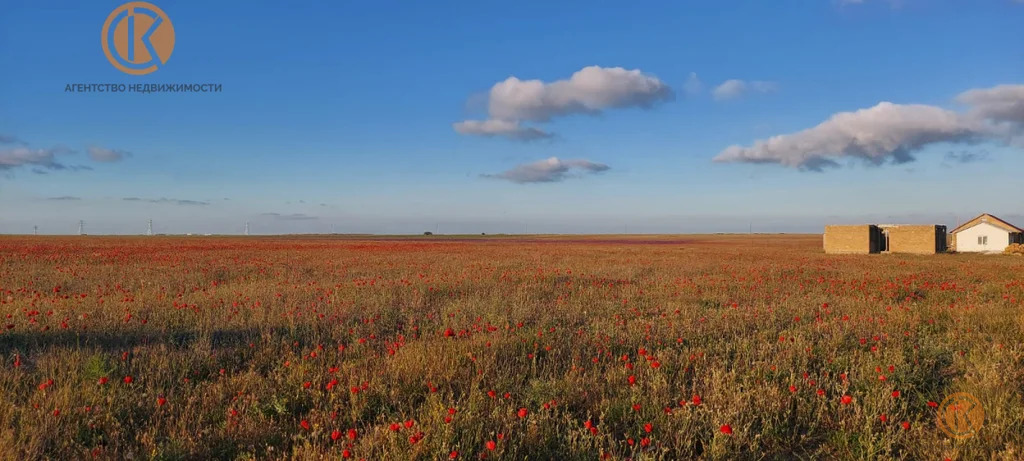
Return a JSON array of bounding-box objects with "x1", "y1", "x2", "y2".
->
[{"x1": 0, "y1": 0, "x2": 1024, "y2": 234}]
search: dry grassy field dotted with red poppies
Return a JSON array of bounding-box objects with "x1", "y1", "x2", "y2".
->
[{"x1": 0, "y1": 236, "x2": 1024, "y2": 460}]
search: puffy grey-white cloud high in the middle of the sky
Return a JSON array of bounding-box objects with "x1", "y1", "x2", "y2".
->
[{"x1": 454, "y1": 66, "x2": 674, "y2": 140}]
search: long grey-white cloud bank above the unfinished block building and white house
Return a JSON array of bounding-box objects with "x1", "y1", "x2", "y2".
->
[{"x1": 715, "y1": 85, "x2": 1024, "y2": 170}]
